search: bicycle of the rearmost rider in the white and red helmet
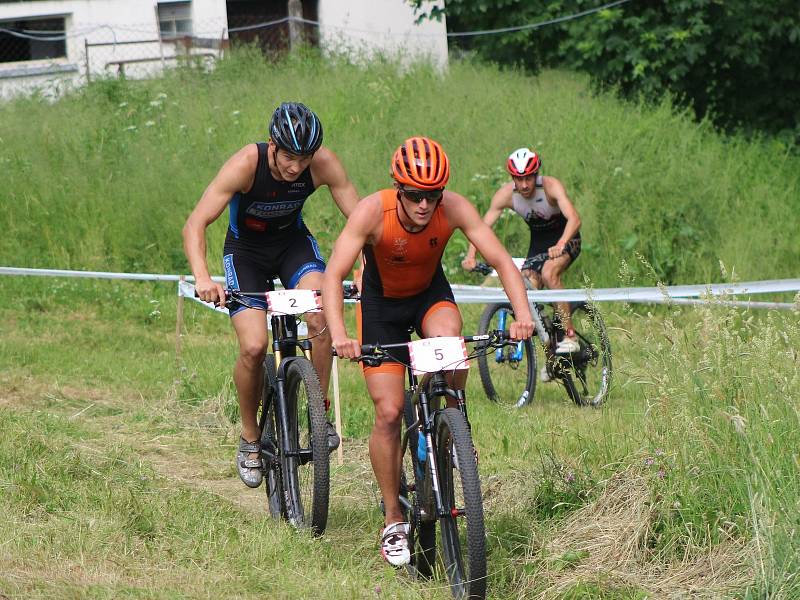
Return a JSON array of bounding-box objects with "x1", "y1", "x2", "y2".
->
[{"x1": 473, "y1": 261, "x2": 612, "y2": 408}]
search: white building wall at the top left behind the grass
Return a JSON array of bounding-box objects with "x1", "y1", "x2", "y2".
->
[{"x1": 0, "y1": 0, "x2": 447, "y2": 98}]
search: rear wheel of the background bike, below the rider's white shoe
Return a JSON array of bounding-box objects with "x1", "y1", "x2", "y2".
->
[{"x1": 561, "y1": 302, "x2": 611, "y2": 406}]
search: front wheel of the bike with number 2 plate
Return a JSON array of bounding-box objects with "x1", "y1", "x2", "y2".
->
[{"x1": 276, "y1": 357, "x2": 330, "y2": 535}]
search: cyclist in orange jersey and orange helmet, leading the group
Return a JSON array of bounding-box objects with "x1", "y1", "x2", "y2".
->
[{"x1": 322, "y1": 137, "x2": 533, "y2": 566}]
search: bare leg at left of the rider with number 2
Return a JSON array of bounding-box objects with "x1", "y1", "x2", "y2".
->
[{"x1": 231, "y1": 308, "x2": 269, "y2": 458}]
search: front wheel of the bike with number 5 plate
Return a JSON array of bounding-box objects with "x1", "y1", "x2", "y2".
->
[{"x1": 429, "y1": 408, "x2": 486, "y2": 598}]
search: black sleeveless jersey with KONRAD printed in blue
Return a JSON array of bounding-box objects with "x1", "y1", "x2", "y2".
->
[{"x1": 226, "y1": 142, "x2": 314, "y2": 245}]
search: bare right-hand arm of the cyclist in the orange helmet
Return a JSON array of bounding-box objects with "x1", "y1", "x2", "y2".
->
[{"x1": 442, "y1": 192, "x2": 533, "y2": 340}]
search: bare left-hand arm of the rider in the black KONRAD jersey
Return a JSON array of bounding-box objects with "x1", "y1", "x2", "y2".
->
[{"x1": 183, "y1": 144, "x2": 258, "y2": 303}]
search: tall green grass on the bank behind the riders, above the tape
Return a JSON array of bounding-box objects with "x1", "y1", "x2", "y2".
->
[{"x1": 0, "y1": 48, "x2": 800, "y2": 285}]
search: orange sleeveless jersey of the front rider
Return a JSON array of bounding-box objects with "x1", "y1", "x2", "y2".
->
[{"x1": 363, "y1": 189, "x2": 453, "y2": 298}]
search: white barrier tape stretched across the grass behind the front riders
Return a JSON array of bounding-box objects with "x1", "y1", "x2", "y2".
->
[{"x1": 0, "y1": 267, "x2": 800, "y2": 308}]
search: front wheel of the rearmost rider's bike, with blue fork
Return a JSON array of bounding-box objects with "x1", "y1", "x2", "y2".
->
[{"x1": 478, "y1": 303, "x2": 536, "y2": 408}]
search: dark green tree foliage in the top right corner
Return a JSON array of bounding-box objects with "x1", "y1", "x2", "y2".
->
[{"x1": 413, "y1": 0, "x2": 800, "y2": 143}]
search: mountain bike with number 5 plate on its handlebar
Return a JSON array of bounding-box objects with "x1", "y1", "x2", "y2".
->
[{"x1": 340, "y1": 332, "x2": 516, "y2": 598}]
